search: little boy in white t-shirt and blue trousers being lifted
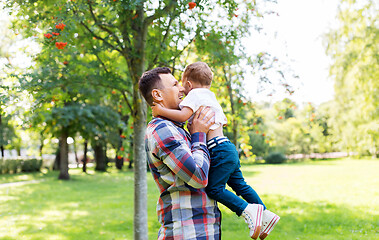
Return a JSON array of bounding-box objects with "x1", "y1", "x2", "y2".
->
[{"x1": 152, "y1": 62, "x2": 280, "y2": 239}]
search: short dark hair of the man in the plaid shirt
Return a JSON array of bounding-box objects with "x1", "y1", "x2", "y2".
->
[{"x1": 138, "y1": 67, "x2": 171, "y2": 106}]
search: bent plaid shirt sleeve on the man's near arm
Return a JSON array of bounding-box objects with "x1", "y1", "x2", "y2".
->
[{"x1": 153, "y1": 124, "x2": 209, "y2": 188}]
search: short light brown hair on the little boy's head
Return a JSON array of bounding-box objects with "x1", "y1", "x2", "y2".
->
[{"x1": 183, "y1": 62, "x2": 213, "y2": 86}]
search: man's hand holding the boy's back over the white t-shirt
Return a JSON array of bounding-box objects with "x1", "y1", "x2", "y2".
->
[{"x1": 188, "y1": 106, "x2": 215, "y2": 134}]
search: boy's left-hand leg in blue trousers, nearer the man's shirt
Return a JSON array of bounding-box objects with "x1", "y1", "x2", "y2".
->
[{"x1": 206, "y1": 142, "x2": 248, "y2": 216}]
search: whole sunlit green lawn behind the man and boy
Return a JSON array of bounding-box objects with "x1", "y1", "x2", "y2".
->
[{"x1": 0, "y1": 160, "x2": 379, "y2": 240}]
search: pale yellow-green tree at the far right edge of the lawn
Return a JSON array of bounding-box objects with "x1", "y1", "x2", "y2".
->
[{"x1": 327, "y1": 0, "x2": 379, "y2": 157}]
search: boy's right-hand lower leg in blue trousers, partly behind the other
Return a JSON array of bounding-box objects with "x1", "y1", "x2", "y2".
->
[{"x1": 228, "y1": 161, "x2": 266, "y2": 209}]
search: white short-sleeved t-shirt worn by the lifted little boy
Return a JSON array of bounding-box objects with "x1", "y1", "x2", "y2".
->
[{"x1": 179, "y1": 88, "x2": 227, "y2": 130}]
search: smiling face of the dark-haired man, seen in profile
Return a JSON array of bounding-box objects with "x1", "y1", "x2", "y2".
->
[{"x1": 159, "y1": 74, "x2": 184, "y2": 109}]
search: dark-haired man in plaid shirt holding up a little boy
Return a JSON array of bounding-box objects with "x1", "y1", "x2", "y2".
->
[{"x1": 139, "y1": 67, "x2": 221, "y2": 240}]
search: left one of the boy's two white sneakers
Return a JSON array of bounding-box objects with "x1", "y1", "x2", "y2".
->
[{"x1": 241, "y1": 204, "x2": 263, "y2": 239}]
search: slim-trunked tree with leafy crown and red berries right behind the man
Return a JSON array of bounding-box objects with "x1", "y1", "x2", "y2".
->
[{"x1": 7, "y1": 0, "x2": 282, "y2": 236}]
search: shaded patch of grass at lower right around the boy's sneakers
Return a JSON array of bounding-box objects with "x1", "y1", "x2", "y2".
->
[{"x1": 221, "y1": 195, "x2": 379, "y2": 240}]
